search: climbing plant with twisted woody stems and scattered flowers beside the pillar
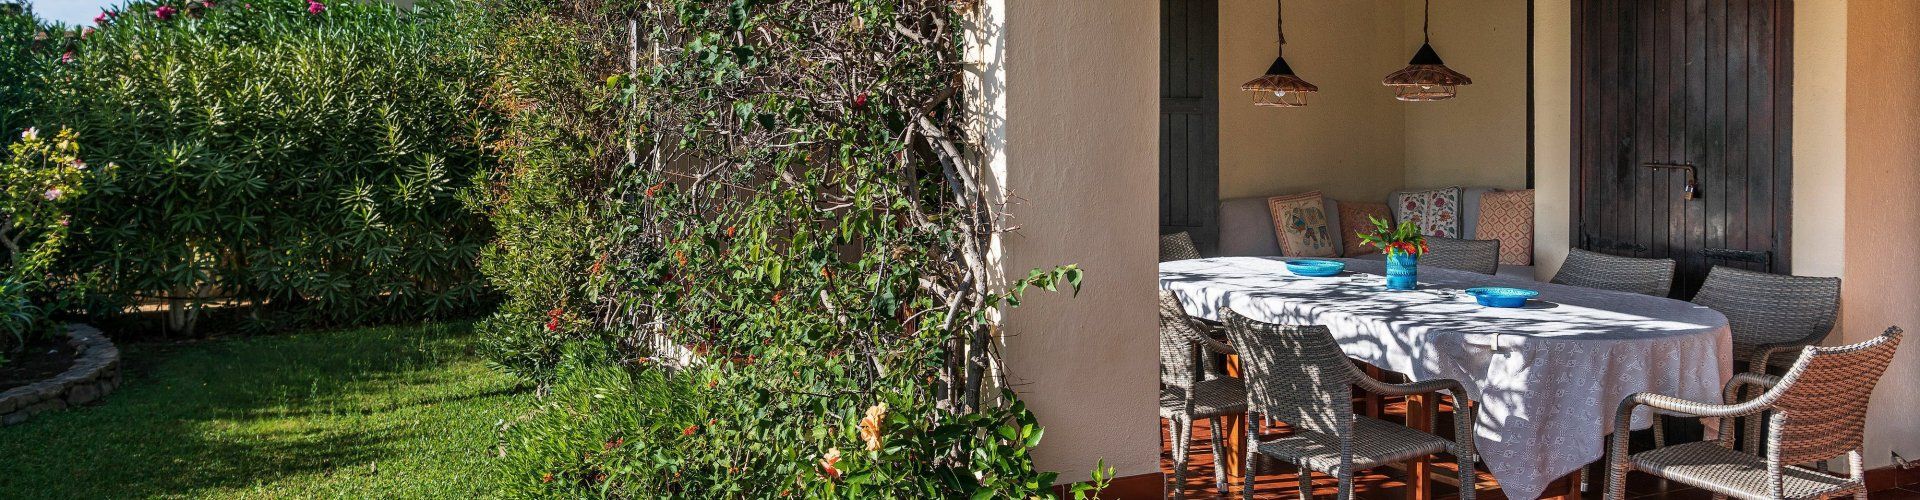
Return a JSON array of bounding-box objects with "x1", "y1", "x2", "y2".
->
[{"x1": 484, "y1": 0, "x2": 1092, "y2": 498}]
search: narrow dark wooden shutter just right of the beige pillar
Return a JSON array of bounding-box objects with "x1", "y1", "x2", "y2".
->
[{"x1": 1160, "y1": 0, "x2": 1219, "y2": 256}]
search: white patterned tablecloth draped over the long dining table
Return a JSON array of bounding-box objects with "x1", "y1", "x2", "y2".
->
[{"x1": 1160, "y1": 258, "x2": 1732, "y2": 498}]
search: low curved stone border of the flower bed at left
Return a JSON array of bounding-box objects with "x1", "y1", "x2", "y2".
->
[{"x1": 0, "y1": 323, "x2": 121, "y2": 425}]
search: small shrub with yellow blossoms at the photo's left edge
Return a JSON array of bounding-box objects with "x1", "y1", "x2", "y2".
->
[{"x1": 0, "y1": 129, "x2": 102, "y2": 362}]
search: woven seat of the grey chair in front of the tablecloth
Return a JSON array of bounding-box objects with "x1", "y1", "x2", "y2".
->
[{"x1": 1258, "y1": 415, "x2": 1453, "y2": 473}]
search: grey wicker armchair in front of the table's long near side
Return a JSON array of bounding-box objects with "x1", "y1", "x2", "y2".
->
[{"x1": 1227, "y1": 312, "x2": 1473, "y2": 500}]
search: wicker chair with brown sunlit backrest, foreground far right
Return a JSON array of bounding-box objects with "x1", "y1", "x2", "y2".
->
[{"x1": 1607, "y1": 327, "x2": 1901, "y2": 500}]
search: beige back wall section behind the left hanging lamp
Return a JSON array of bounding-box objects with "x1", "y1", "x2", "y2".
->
[{"x1": 1219, "y1": 0, "x2": 1417, "y2": 200}]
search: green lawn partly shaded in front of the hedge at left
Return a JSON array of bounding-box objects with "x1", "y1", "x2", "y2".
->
[{"x1": 0, "y1": 323, "x2": 532, "y2": 498}]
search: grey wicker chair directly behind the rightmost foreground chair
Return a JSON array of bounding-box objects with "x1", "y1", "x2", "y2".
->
[{"x1": 1697, "y1": 265, "x2": 1839, "y2": 452}]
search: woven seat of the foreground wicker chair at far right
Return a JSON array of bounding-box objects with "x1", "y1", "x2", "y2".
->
[{"x1": 1632, "y1": 440, "x2": 1860, "y2": 498}]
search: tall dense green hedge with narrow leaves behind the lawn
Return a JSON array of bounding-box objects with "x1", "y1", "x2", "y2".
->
[{"x1": 36, "y1": 0, "x2": 492, "y2": 336}]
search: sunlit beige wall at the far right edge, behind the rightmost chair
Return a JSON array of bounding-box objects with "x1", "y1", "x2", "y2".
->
[{"x1": 1843, "y1": 0, "x2": 1920, "y2": 467}]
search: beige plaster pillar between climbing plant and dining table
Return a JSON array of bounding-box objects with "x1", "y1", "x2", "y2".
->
[{"x1": 966, "y1": 0, "x2": 1160, "y2": 481}]
